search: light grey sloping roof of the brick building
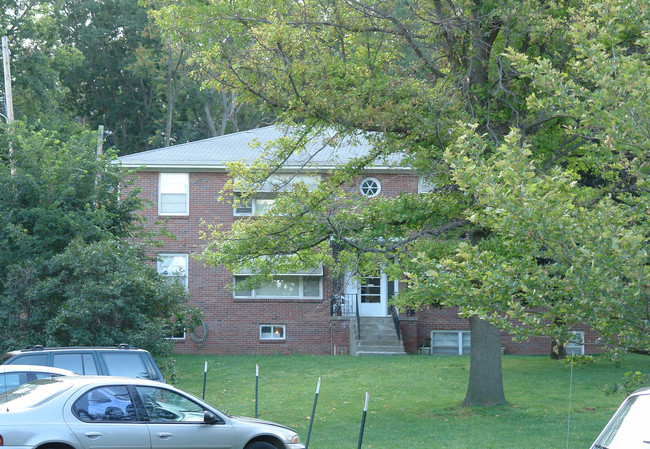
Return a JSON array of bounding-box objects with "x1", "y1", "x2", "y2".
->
[{"x1": 118, "y1": 126, "x2": 399, "y2": 171}]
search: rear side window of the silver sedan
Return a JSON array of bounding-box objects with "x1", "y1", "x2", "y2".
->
[{"x1": 72, "y1": 385, "x2": 137, "y2": 422}]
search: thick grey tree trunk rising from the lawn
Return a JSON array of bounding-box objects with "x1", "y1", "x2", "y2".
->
[{"x1": 463, "y1": 316, "x2": 506, "y2": 407}]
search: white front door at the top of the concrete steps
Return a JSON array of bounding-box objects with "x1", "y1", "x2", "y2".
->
[{"x1": 346, "y1": 274, "x2": 396, "y2": 316}]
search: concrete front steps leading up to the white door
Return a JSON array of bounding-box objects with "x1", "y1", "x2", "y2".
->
[{"x1": 350, "y1": 317, "x2": 406, "y2": 355}]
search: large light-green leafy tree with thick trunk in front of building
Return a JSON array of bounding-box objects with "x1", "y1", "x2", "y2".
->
[{"x1": 158, "y1": 0, "x2": 649, "y2": 405}]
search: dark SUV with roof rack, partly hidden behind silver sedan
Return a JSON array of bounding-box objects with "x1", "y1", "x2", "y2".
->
[{"x1": 2, "y1": 344, "x2": 165, "y2": 382}]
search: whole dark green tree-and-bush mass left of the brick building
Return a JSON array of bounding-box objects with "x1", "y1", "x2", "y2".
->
[{"x1": 0, "y1": 122, "x2": 191, "y2": 354}]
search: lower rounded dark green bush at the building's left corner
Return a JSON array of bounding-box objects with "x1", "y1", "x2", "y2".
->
[{"x1": 40, "y1": 240, "x2": 189, "y2": 354}]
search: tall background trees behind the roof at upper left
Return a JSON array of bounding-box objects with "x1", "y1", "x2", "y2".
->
[{"x1": 0, "y1": 0, "x2": 268, "y2": 154}]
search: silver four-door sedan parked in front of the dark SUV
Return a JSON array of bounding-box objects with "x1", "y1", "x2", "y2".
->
[{"x1": 0, "y1": 376, "x2": 304, "y2": 449}]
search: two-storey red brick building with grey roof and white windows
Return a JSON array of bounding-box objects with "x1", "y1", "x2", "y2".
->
[{"x1": 120, "y1": 126, "x2": 595, "y2": 354}]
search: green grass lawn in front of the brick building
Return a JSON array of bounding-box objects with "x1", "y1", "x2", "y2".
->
[{"x1": 168, "y1": 355, "x2": 650, "y2": 449}]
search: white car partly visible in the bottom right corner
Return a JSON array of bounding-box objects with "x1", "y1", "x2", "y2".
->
[{"x1": 594, "y1": 394, "x2": 650, "y2": 449}]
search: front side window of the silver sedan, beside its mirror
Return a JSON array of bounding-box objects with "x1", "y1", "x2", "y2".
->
[{"x1": 136, "y1": 387, "x2": 205, "y2": 423}]
